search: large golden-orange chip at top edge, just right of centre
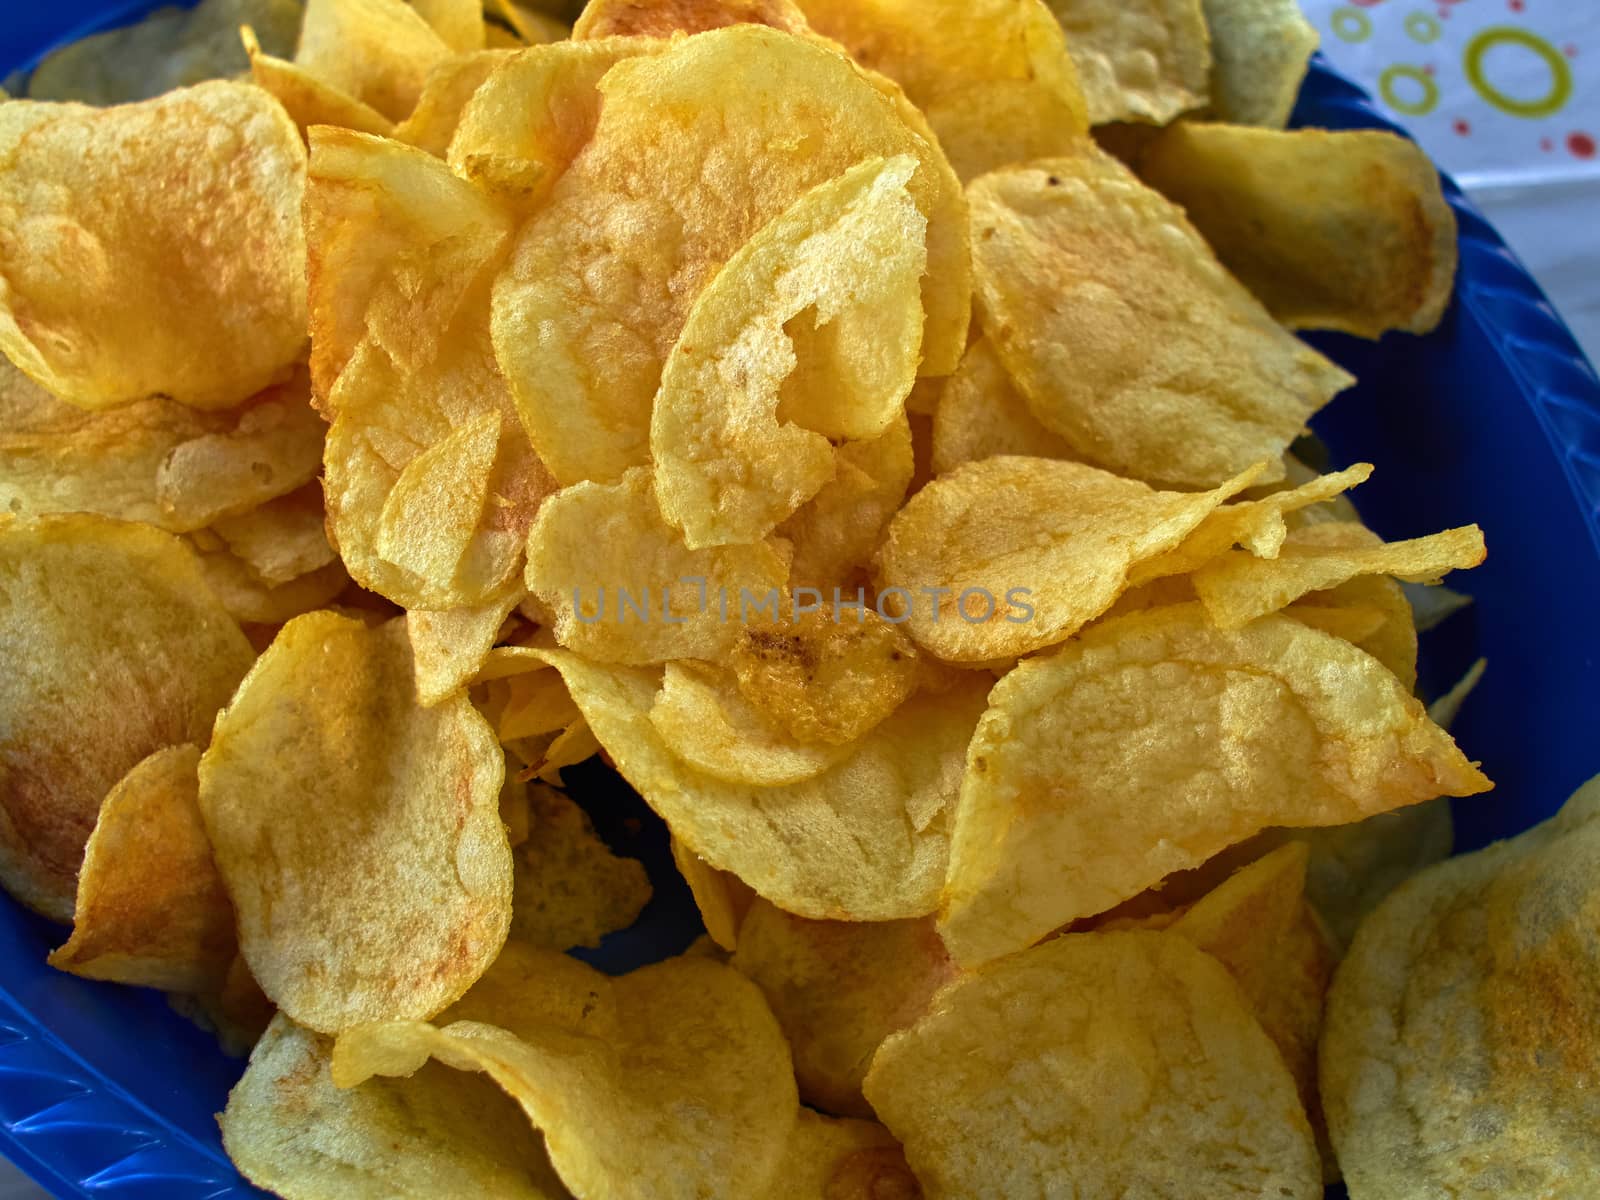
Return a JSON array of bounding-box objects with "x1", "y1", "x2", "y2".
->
[{"x1": 800, "y1": 0, "x2": 1088, "y2": 179}]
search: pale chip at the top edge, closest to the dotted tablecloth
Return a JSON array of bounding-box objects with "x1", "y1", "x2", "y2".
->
[{"x1": 1202, "y1": 0, "x2": 1320, "y2": 128}]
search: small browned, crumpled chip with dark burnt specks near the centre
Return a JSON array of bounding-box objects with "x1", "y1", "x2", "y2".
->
[{"x1": 728, "y1": 614, "x2": 918, "y2": 746}]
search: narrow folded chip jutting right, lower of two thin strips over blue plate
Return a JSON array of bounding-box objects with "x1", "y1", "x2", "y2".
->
[{"x1": 1194, "y1": 523, "x2": 1486, "y2": 640}]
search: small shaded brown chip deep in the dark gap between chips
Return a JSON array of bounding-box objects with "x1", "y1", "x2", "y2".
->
[{"x1": 510, "y1": 784, "x2": 650, "y2": 950}]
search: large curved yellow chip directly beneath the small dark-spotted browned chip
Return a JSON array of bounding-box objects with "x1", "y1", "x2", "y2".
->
[{"x1": 542, "y1": 651, "x2": 986, "y2": 920}]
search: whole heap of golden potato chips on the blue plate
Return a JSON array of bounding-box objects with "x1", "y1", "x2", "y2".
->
[{"x1": 0, "y1": 0, "x2": 1600, "y2": 1200}]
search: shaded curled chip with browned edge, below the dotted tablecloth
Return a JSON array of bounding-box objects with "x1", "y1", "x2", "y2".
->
[{"x1": 1139, "y1": 122, "x2": 1458, "y2": 338}]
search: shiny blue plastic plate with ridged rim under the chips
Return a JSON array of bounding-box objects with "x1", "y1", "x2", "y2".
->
[{"x1": 0, "y1": 9, "x2": 1600, "y2": 1200}]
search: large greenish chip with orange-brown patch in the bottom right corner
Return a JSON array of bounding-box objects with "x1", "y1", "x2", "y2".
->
[{"x1": 1322, "y1": 781, "x2": 1600, "y2": 1200}]
